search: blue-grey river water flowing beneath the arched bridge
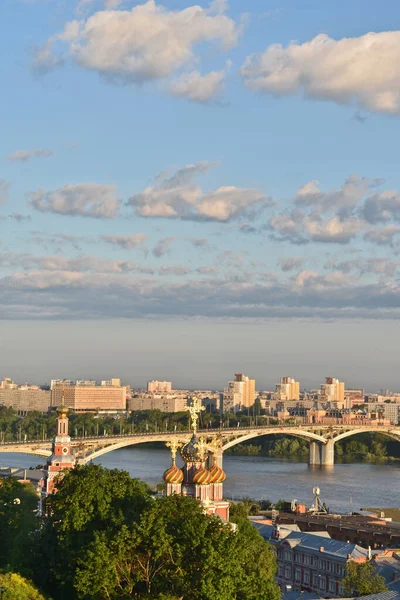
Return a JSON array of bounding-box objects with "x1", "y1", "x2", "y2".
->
[{"x1": 0, "y1": 445, "x2": 400, "y2": 512}]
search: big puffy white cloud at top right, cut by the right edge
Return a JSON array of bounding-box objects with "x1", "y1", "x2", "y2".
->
[{"x1": 241, "y1": 31, "x2": 400, "y2": 115}]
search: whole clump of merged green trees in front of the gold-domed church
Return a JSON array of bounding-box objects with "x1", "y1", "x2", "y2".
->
[{"x1": 22, "y1": 465, "x2": 279, "y2": 600}]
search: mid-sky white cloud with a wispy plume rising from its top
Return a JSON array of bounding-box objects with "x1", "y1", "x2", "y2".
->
[{"x1": 128, "y1": 162, "x2": 271, "y2": 222}]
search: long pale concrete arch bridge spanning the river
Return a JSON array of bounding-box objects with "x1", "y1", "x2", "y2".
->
[{"x1": 0, "y1": 424, "x2": 400, "y2": 466}]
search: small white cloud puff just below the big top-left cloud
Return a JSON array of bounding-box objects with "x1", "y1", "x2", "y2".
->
[{"x1": 168, "y1": 71, "x2": 225, "y2": 104}]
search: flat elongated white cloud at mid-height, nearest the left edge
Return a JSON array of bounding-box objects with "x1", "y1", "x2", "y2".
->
[{"x1": 30, "y1": 183, "x2": 120, "y2": 219}]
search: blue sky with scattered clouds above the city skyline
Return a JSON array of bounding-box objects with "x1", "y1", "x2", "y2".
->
[{"x1": 0, "y1": 0, "x2": 400, "y2": 391}]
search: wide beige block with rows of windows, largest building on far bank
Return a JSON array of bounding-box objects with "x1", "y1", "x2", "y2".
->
[{"x1": 51, "y1": 385, "x2": 127, "y2": 412}]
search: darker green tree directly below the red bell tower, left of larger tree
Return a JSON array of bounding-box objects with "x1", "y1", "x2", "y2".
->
[{"x1": 31, "y1": 464, "x2": 153, "y2": 600}]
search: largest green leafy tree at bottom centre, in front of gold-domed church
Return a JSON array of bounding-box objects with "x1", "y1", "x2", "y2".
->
[{"x1": 75, "y1": 496, "x2": 279, "y2": 600}]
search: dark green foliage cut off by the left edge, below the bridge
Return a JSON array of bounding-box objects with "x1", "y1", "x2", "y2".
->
[{"x1": 0, "y1": 478, "x2": 38, "y2": 568}]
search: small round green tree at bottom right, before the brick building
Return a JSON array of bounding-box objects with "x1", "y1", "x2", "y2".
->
[{"x1": 342, "y1": 561, "x2": 387, "y2": 597}]
